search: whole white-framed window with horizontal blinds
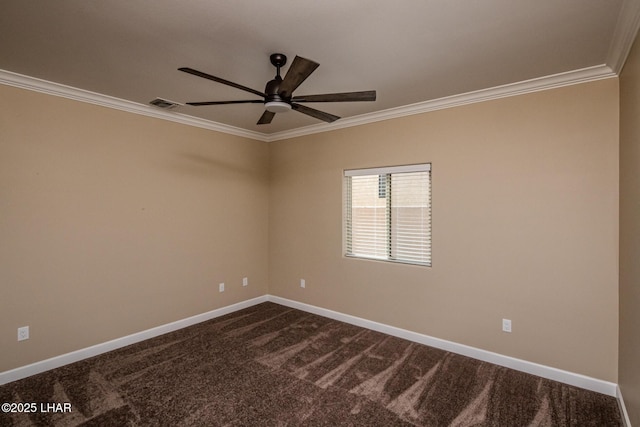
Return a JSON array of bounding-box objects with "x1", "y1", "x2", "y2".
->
[{"x1": 344, "y1": 163, "x2": 431, "y2": 266}]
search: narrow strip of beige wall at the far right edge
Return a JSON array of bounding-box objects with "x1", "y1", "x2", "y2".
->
[{"x1": 619, "y1": 29, "x2": 640, "y2": 425}]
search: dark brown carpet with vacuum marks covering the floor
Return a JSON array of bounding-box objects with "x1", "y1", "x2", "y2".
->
[{"x1": 0, "y1": 303, "x2": 622, "y2": 427}]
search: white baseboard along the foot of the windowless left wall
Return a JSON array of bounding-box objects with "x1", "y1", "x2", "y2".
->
[{"x1": 0, "y1": 295, "x2": 268, "y2": 385}]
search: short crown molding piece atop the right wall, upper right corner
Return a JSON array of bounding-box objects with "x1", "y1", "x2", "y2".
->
[{"x1": 607, "y1": 0, "x2": 640, "y2": 75}]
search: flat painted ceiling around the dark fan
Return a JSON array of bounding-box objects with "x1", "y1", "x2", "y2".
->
[{"x1": 0, "y1": 0, "x2": 639, "y2": 140}]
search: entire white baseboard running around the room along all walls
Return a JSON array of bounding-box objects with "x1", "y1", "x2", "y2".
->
[{"x1": 0, "y1": 295, "x2": 626, "y2": 402}]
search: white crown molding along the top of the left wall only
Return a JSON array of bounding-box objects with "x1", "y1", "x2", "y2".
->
[{"x1": 0, "y1": 70, "x2": 266, "y2": 142}]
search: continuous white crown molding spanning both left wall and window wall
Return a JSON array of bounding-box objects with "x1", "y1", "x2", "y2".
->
[{"x1": 0, "y1": 65, "x2": 616, "y2": 142}]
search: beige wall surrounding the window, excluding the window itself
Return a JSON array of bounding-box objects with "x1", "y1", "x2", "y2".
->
[{"x1": 269, "y1": 79, "x2": 618, "y2": 382}]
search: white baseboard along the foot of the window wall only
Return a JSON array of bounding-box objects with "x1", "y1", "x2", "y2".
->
[{"x1": 268, "y1": 295, "x2": 620, "y2": 401}]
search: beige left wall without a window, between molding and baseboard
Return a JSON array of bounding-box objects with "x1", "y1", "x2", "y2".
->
[{"x1": 0, "y1": 86, "x2": 269, "y2": 371}]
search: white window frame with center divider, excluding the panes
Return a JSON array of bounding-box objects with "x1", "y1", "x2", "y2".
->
[{"x1": 342, "y1": 163, "x2": 433, "y2": 267}]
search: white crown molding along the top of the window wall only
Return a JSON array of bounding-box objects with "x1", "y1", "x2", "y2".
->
[{"x1": 267, "y1": 65, "x2": 616, "y2": 142}]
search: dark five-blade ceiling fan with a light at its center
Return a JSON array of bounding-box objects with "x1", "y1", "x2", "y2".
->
[{"x1": 178, "y1": 53, "x2": 376, "y2": 125}]
